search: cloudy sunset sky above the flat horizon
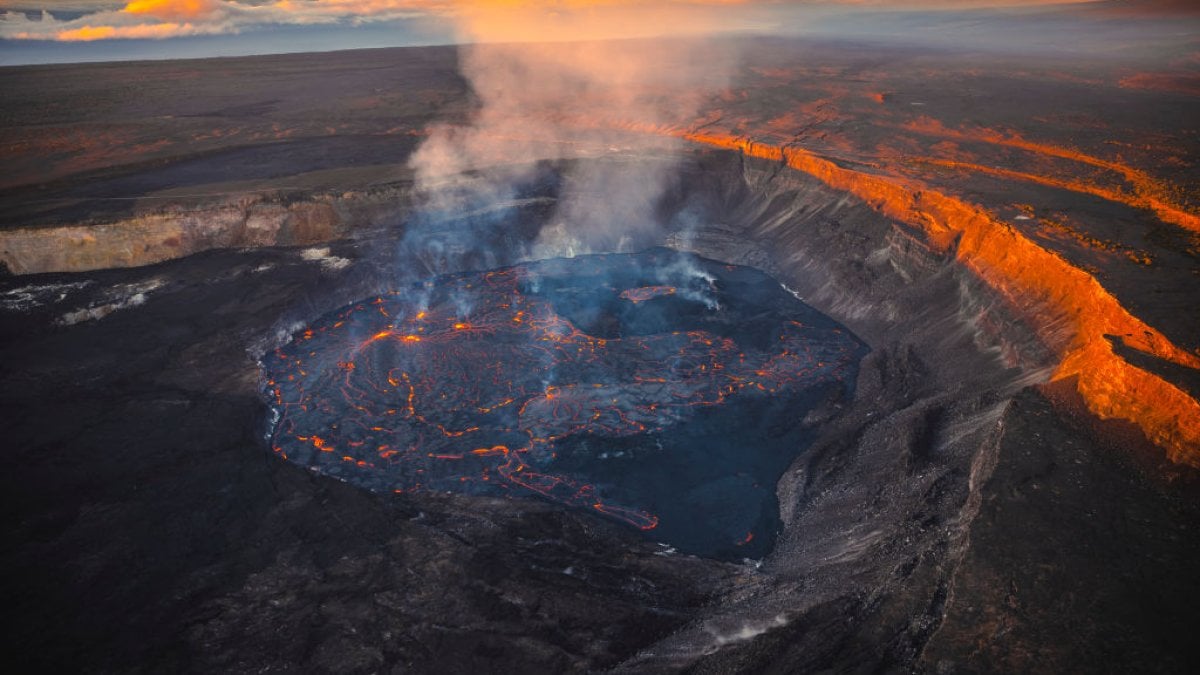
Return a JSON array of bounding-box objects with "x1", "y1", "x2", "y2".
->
[{"x1": 0, "y1": 0, "x2": 1200, "y2": 65}]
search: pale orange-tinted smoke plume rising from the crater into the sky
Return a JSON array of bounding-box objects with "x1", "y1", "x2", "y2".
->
[{"x1": 409, "y1": 2, "x2": 736, "y2": 270}]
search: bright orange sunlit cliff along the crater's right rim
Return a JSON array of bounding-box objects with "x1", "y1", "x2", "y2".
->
[{"x1": 683, "y1": 133, "x2": 1200, "y2": 466}]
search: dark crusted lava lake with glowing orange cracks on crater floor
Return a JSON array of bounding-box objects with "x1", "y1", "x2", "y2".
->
[{"x1": 264, "y1": 250, "x2": 865, "y2": 557}]
